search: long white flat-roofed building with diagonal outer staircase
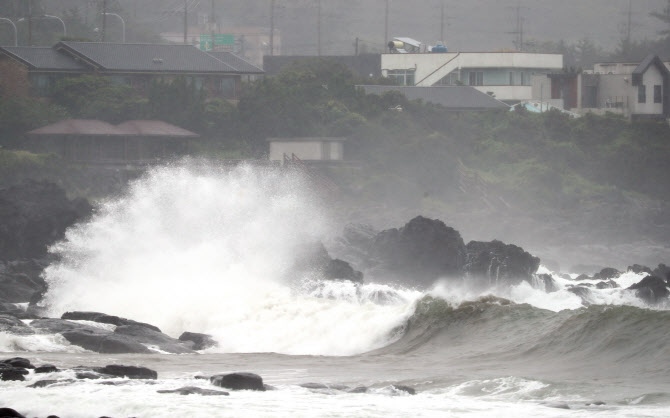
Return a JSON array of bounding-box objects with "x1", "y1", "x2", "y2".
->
[{"x1": 381, "y1": 52, "x2": 563, "y2": 102}]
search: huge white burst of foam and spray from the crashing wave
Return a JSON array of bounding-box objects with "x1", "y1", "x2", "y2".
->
[{"x1": 39, "y1": 165, "x2": 413, "y2": 355}]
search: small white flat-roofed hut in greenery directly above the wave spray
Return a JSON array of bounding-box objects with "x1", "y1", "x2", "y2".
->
[{"x1": 267, "y1": 137, "x2": 346, "y2": 165}]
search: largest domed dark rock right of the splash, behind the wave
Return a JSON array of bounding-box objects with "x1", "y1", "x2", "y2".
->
[{"x1": 370, "y1": 216, "x2": 465, "y2": 286}]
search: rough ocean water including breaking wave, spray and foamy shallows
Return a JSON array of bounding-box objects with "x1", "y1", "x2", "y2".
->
[{"x1": 0, "y1": 165, "x2": 670, "y2": 417}]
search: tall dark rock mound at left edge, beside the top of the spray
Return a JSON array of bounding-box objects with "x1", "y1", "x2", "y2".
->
[{"x1": 0, "y1": 180, "x2": 92, "y2": 260}]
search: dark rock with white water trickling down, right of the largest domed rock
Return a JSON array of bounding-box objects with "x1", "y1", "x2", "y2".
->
[{"x1": 463, "y1": 240, "x2": 540, "y2": 285}]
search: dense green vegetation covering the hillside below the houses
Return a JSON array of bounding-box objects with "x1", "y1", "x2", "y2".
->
[{"x1": 0, "y1": 59, "x2": 670, "y2": 245}]
